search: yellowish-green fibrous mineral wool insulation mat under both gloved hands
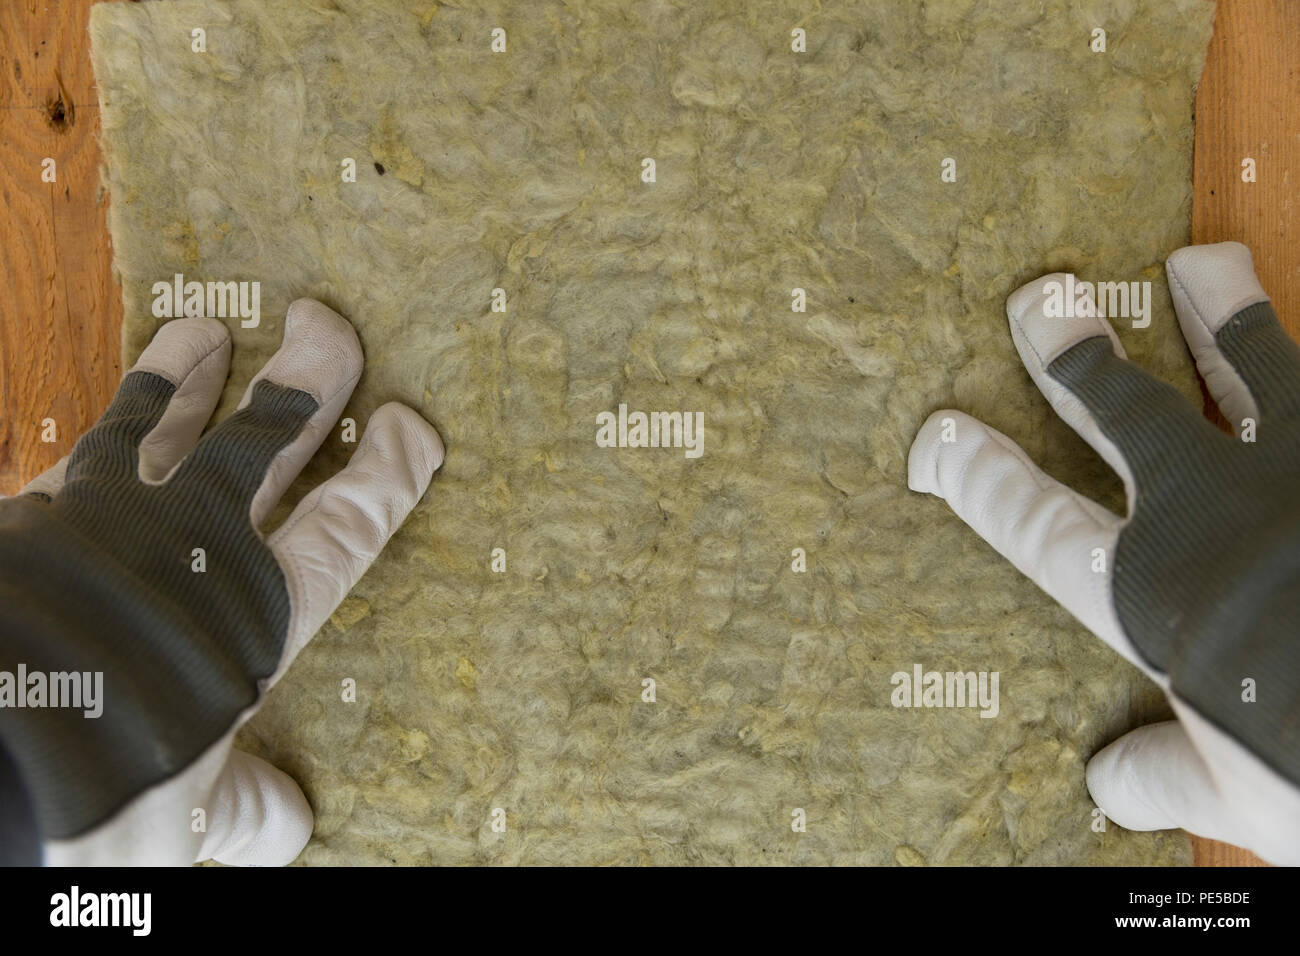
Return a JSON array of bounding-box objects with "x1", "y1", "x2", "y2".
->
[{"x1": 91, "y1": 0, "x2": 1213, "y2": 864}]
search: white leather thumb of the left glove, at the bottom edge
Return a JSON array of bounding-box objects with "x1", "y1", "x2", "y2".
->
[{"x1": 196, "y1": 750, "x2": 313, "y2": 866}]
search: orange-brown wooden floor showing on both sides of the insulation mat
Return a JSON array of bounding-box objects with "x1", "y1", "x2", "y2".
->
[{"x1": 0, "y1": 0, "x2": 1300, "y2": 866}]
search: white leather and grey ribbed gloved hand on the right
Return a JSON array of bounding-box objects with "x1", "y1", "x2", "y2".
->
[{"x1": 907, "y1": 242, "x2": 1300, "y2": 864}]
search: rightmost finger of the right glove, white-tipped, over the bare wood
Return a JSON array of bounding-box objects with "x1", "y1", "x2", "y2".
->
[{"x1": 1165, "y1": 242, "x2": 1300, "y2": 433}]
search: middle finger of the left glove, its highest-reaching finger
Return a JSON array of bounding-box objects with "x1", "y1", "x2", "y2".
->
[{"x1": 173, "y1": 299, "x2": 363, "y2": 528}]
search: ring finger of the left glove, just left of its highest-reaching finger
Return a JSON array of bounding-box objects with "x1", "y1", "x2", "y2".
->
[{"x1": 65, "y1": 319, "x2": 230, "y2": 483}]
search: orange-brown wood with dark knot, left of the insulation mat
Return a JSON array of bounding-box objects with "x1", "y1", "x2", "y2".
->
[{"x1": 0, "y1": 0, "x2": 122, "y2": 494}]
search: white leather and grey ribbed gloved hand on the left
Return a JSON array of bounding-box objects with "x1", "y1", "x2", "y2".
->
[{"x1": 0, "y1": 299, "x2": 443, "y2": 865}]
